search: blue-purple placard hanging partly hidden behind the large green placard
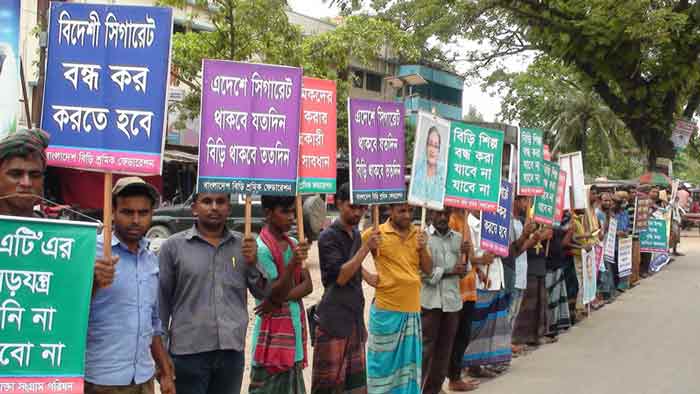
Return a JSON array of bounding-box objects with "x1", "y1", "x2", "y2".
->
[{"x1": 480, "y1": 180, "x2": 513, "y2": 257}]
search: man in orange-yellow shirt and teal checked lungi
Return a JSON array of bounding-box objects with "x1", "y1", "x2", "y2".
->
[{"x1": 362, "y1": 204, "x2": 433, "y2": 394}]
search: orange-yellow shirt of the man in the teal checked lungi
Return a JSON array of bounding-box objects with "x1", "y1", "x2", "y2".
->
[{"x1": 362, "y1": 219, "x2": 421, "y2": 312}]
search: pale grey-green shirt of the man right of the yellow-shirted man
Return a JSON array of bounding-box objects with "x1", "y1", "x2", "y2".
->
[{"x1": 421, "y1": 226, "x2": 462, "y2": 312}]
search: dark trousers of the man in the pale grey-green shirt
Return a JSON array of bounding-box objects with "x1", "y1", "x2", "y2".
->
[{"x1": 421, "y1": 309, "x2": 461, "y2": 394}]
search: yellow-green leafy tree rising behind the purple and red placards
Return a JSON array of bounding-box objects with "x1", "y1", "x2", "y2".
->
[{"x1": 161, "y1": 0, "x2": 419, "y2": 149}]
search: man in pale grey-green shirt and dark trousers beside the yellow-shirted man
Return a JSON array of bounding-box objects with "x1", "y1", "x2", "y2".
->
[{"x1": 421, "y1": 207, "x2": 471, "y2": 394}]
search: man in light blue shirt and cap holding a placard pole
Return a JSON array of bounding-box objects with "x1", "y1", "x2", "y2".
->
[{"x1": 85, "y1": 177, "x2": 175, "y2": 394}]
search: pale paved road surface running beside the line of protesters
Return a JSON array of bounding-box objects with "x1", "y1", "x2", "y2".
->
[{"x1": 464, "y1": 234, "x2": 700, "y2": 394}]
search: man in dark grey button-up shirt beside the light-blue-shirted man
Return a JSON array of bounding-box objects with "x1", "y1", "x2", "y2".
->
[{"x1": 160, "y1": 193, "x2": 267, "y2": 394}]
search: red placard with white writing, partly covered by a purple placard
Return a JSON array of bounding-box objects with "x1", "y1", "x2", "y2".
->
[{"x1": 298, "y1": 77, "x2": 338, "y2": 194}]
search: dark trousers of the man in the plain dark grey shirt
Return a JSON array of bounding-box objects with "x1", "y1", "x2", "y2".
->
[{"x1": 172, "y1": 350, "x2": 244, "y2": 394}]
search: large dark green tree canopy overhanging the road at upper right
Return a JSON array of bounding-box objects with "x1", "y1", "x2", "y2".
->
[{"x1": 336, "y1": 0, "x2": 700, "y2": 168}]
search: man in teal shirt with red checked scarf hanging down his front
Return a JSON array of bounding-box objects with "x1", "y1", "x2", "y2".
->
[{"x1": 248, "y1": 196, "x2": 313, "y2": 394}]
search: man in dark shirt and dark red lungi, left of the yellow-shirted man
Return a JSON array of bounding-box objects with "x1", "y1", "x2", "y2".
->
[{"x1": 311, "y1": 183, "x2": 380, "y2": 394}]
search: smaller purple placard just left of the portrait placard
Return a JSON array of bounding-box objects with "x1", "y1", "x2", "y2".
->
[{"x1": 348, "y1": 99, "x2": 406, "y2": 204}]
